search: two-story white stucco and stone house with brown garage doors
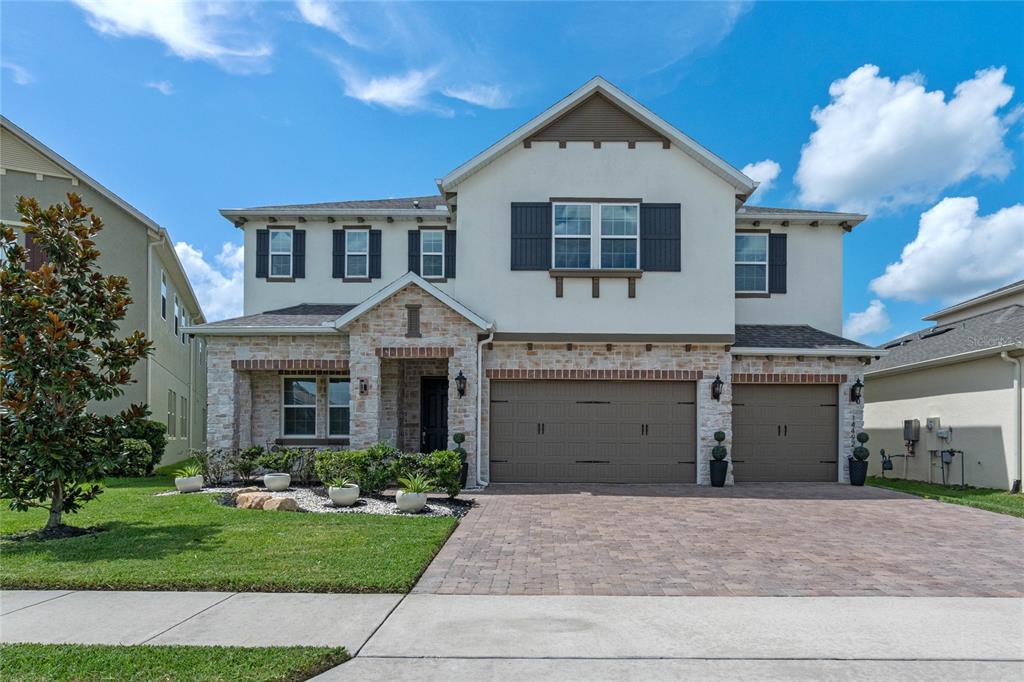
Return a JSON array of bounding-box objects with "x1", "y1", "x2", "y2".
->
[{"x1": 188, "y1": 78, "x2": 879, "y2": 484}]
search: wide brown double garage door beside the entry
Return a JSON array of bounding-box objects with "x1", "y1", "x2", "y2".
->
[{"x1": 490, "y1": 381, "x2": 696, "y2": 483}]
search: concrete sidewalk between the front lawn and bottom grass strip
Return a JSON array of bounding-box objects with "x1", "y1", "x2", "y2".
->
[{"x1": 0, "y1": 590, "x2": 401, "y2": 652}]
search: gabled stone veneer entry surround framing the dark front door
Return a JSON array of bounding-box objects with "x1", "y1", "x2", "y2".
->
[{"x1": 347, "y1": 285, "x2": 481, "y2": 478}]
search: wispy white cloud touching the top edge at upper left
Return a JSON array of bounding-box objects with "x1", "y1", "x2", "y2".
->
[{"x1": 74, "y1": 0, "x2": 272, "y2": 72}]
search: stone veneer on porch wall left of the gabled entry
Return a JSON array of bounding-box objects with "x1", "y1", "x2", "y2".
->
[{"x1": 207, "y1": 334, "x2": 348, "y2": 447}]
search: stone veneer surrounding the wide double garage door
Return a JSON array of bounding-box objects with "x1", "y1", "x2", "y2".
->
[{"x1": 480, "y1": 342, "x2": 732, "y2": 484}]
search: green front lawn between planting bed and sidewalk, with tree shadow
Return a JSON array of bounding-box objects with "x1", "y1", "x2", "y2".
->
[{"x1": 0, "y1": 475, "x2": 457, "y2": 592}]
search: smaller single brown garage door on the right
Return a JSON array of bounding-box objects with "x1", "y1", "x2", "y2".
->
[{"x1": 732, "y1": 384, "x2": 839, "y2": 482}]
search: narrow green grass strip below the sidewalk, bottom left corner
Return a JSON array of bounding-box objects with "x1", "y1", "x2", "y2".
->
[{"x1": 0, "y1": 644, "x2": 348, "y2": 682}]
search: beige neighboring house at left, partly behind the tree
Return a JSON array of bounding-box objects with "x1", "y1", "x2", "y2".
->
[{"x1": 0, "y1": 117, "x2": 206, "y2": 463}]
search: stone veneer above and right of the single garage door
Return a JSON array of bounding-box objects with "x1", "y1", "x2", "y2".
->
[{"x1": 732, "y1": 355, "x2": 867, "y2": 482}]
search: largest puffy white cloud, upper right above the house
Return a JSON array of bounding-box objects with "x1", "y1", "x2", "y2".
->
[{"x1": 795, "y1": 65, "x2": 1014, "y2": 211}]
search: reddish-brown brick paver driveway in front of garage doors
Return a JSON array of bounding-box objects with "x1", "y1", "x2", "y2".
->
[{"x1": 414, "y1": 483, "x2": 1024, "y2": 597}]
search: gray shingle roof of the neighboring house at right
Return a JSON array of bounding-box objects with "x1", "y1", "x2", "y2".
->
[{"x1": 871, "y1": 305, "x2": 1024, "y2": 372}]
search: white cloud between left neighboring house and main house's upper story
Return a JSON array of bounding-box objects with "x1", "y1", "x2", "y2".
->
[{"x1": 174, "y1": 242, "x2": 245, "y2": 322}]
